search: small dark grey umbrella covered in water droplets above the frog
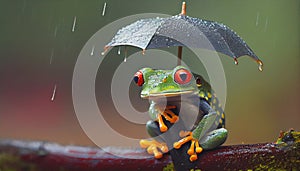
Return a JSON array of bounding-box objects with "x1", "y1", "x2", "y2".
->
[{"x1": 104, "y1": 2, "x2": 263, "y2": 71}]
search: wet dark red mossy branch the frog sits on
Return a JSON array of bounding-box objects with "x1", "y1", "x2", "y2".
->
[{"x1": 0, "y1": 131, "x2": 300, "y2": 171}]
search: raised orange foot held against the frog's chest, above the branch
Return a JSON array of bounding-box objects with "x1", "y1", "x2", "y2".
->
[{"x1": 157, "y1": 106, "x2": 178, "y2": 132}]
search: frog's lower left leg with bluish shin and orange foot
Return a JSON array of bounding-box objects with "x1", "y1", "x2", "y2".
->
[{"x1": 140, "y1": 121, "x2": 169, "y2": 159}]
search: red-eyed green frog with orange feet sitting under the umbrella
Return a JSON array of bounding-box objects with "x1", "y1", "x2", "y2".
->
[{"x1": 133, "y1": 65, "x2": 228, "y2": 162}]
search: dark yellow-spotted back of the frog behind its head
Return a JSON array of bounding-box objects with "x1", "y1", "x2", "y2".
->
[{"x1": 193, "y1": 73, "x2": 225, "y2": 128}]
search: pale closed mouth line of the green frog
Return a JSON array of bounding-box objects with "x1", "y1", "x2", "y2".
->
[{"x1": 141, "y1": 90, "x2": 195, "y2": 99}]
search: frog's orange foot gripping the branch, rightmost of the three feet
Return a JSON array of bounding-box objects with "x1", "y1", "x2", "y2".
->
[{"x1": 173, "y1": 131, "x2": 203, "y2": 162}]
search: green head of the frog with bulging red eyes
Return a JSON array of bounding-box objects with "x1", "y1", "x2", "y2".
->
[{"x1": 133, "y1": 66, "x2": 199, "y2": 99}]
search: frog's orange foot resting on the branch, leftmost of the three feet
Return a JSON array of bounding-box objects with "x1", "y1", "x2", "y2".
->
[{"x1": 140, "y1": 139, "x2": 169, "y2": 159}]
